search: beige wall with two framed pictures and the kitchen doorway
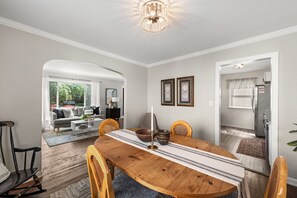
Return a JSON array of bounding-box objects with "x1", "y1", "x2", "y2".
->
[{"x1": 148, "y1": 33, "x2": 297, "y2": 178}]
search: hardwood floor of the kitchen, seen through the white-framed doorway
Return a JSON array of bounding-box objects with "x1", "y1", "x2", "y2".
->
[{"x1": 220, "y1": 127, "x2": 270, "y2": 175}]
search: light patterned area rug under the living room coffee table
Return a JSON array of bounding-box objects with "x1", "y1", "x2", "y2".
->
[{"x1": 42, "y1": 130, "x2": 98, "y2": 147}]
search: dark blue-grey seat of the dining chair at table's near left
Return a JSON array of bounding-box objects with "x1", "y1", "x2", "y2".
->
[{"x1": 112, "y1": 172, "x2": 158, "y2": 198}]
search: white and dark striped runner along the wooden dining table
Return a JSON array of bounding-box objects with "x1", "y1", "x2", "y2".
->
[{"x1": 106, "y1": 129, "x2": 245, "y2": 197}]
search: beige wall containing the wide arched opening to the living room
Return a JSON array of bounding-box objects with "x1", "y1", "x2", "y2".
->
[{"x1": 0, "y1": 25, "x2": 147, "y2": 168}]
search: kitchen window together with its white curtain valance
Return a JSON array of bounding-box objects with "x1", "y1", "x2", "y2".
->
[{"x1": 228, "y1": 78, "x2": 257, "y2": 109}]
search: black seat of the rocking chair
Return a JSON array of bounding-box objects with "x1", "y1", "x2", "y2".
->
[{"x1": 0, "y1": 168, "x2": 37, "y2": 195}]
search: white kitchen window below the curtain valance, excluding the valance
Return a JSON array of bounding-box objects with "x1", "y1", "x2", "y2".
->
[{"x1": 229, "y1": 88, "x2": 254, "y2": 109}]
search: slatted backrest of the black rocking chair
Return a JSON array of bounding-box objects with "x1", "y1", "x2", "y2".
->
[{"x1": 0, "y1": 121, "x2": 19, "y2": 173}]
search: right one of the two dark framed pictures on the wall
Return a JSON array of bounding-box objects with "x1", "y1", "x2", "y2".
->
[{"x1": 177, "y1": 76, "x2": 194, "y2": 107}]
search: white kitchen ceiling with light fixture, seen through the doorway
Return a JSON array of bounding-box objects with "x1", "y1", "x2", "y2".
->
[{"x1": 221, "y1": 59, "x2": 271, "y2": 75}]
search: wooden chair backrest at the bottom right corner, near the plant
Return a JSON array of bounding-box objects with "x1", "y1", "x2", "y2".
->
[{"x1": 264, "y1": 156, "x2": 288, "y2": 198}]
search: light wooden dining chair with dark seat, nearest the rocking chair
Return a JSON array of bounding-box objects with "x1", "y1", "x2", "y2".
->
[{"x1": 87, "y1": 145, "x2": 158, "y2": 198}]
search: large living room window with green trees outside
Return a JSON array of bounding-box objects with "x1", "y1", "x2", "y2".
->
[{"x1": 49, "y1": 81, "x2": 92, "y2": 110}]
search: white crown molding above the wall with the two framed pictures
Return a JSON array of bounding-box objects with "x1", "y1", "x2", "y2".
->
[{"x1": 147, "y1": 26, "x2": 297, "y2": 67}]
